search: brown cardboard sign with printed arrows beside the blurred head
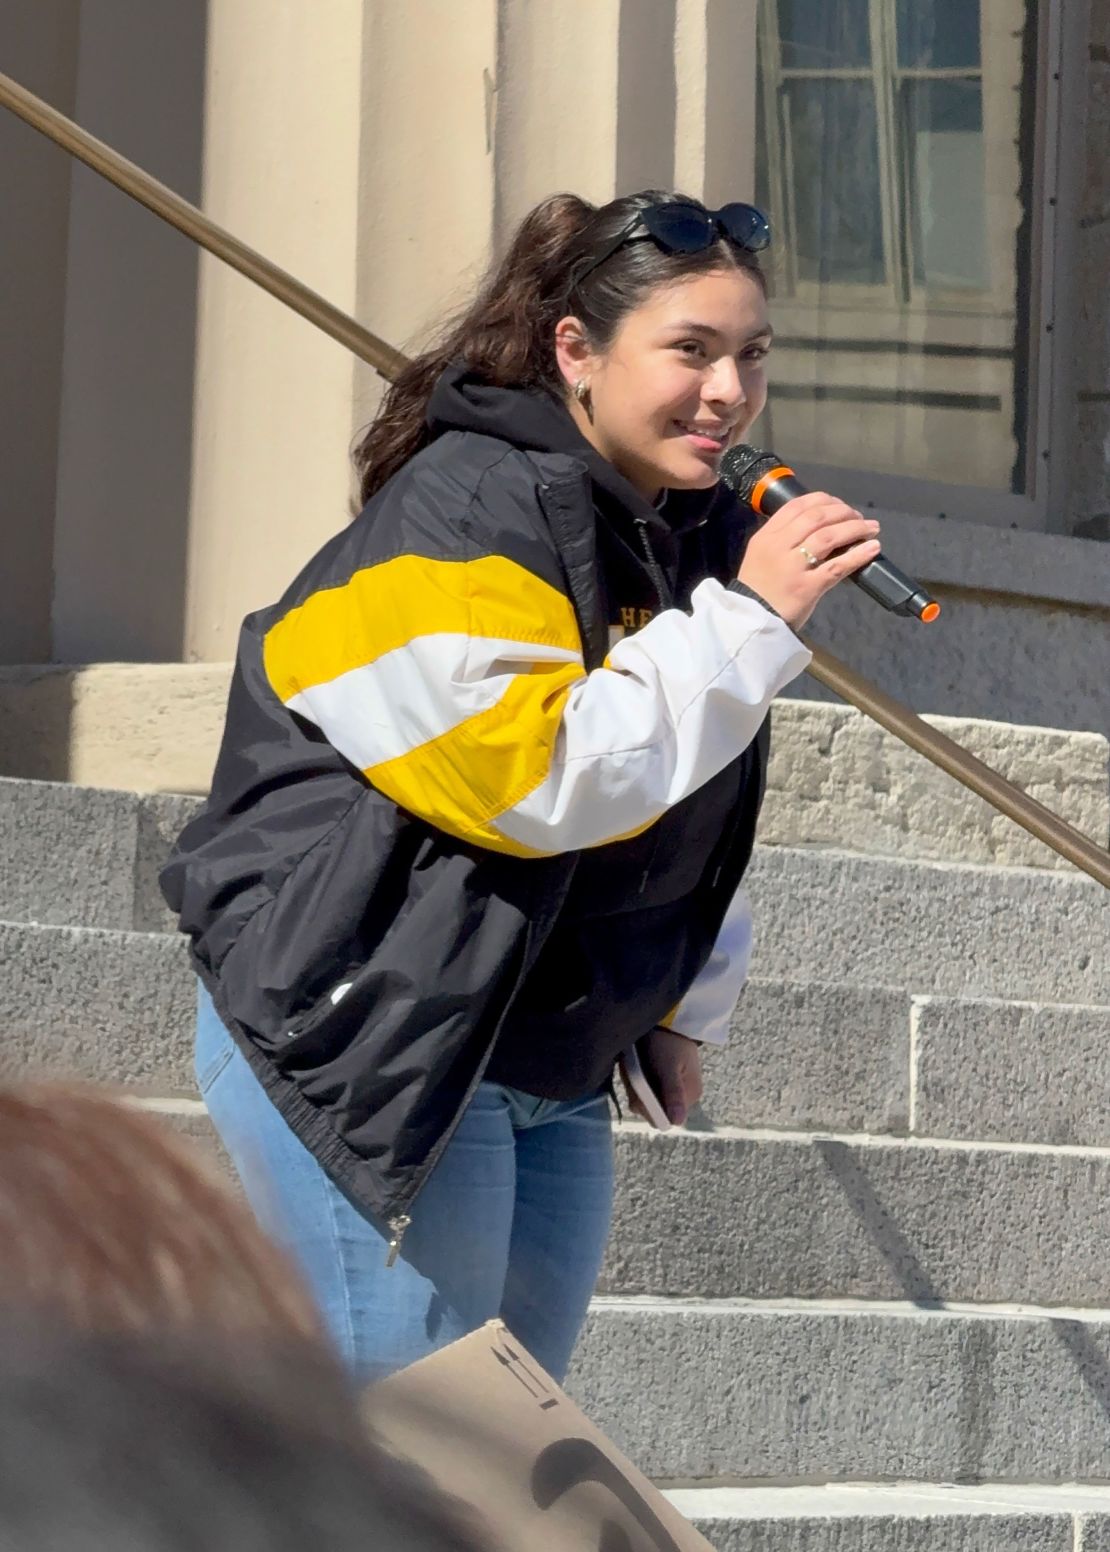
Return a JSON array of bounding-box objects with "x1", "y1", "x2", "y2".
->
[{"x1": 366, "y1": 1321, "x2": 713, "y2": 1552}]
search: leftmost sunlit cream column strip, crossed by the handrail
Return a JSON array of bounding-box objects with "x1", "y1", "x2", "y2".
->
[{"x1": 182, "y1": 0, "x2": 364, "y2": 661}]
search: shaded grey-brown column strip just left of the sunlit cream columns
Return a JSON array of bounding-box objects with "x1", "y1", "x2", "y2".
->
[{"x1": 50, "y1": 0, "x2": 205, "y2": 663}]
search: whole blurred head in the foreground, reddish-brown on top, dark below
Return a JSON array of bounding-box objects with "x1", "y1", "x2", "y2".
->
[{"x1": 0, "y1": 1083, "x2": 481, "y2": 1552}]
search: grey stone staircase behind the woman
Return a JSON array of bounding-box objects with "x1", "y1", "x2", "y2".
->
[{"x1": 0, "y1": 702, "x2": 1110, "y2": 1552}]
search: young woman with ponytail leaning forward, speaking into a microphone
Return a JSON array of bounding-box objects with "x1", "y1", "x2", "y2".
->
[{"x1": 163, "y1": 192, "x2": 879, "y2": 1378}]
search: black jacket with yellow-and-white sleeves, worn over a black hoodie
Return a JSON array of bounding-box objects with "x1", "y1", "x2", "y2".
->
[{"x1": 163, "y1": 369, "x2": 807, "y2": 1241}]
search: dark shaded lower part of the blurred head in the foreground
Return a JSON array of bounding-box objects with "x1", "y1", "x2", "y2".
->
[{"x1": 0, "y1": 1325, "x2": 481, "y2": 1552}]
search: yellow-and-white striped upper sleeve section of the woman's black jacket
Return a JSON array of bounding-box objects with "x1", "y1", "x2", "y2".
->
[{"x1": 264, "y1": 556, "x2": 585, "y2": 857}]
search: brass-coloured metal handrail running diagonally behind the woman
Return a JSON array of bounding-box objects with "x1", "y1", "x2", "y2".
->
[{"x1": 0, "y1": 66, "x2": 1110, "y2": 889}]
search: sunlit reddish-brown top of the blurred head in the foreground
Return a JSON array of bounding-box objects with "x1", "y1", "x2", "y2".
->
[{"x1": 0, "y1": 1083, "x2": 321, "y2": 1342}]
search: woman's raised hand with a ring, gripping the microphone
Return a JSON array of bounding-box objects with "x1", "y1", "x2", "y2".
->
[{"x1": 739, "y1": 490, "x2": 879, "y2": 630}]
